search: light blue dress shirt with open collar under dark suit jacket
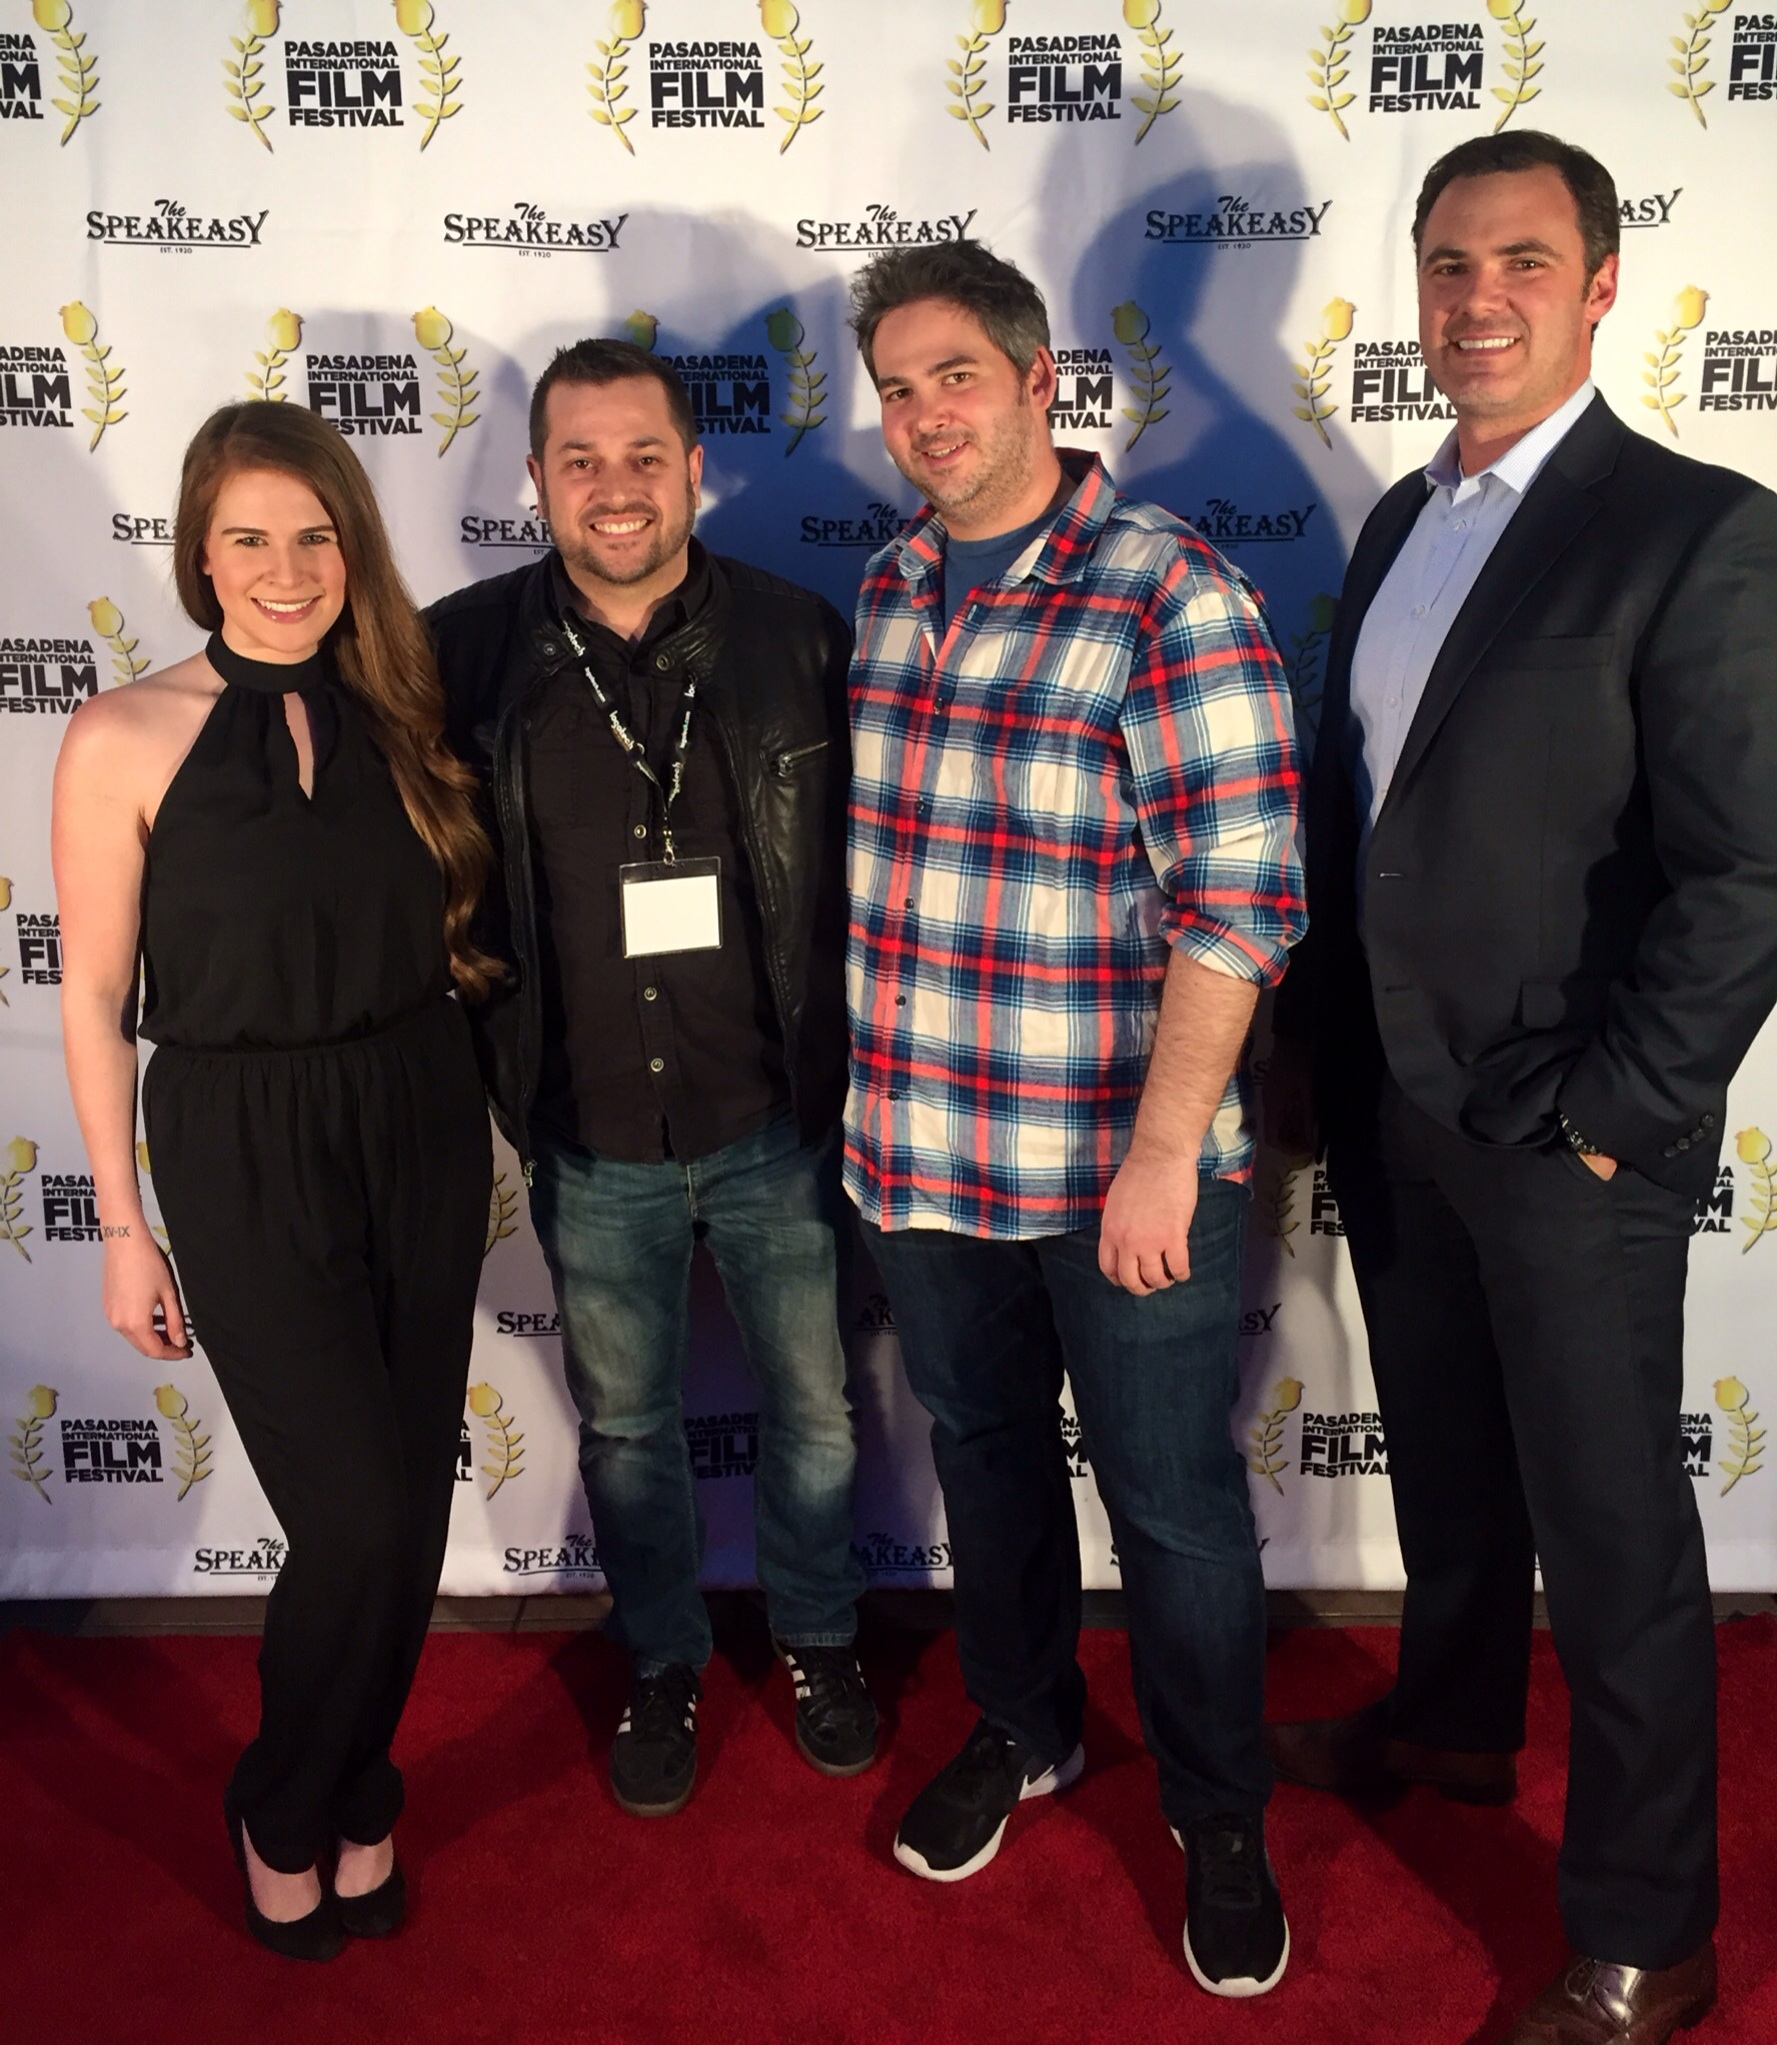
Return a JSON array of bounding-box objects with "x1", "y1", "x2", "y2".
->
[{"x1": 1352, "y1": 380, "x2": 1597, "y2": 846}]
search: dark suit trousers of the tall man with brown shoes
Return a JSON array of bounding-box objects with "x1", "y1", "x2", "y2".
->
[{"x1": 1327, "y1": 1078, "x2": 1716, "y2": 1967}]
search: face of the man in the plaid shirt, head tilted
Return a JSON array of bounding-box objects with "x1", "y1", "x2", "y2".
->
[{"x1": 871, "y1": 299, "x2": 1057, "y2": 540}]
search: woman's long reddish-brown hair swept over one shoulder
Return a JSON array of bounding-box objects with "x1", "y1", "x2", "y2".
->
[{"x1": 172, "y1": 399, "x2": 503, "y2": 998}]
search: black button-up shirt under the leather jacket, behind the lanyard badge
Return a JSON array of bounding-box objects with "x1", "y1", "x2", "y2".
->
[{"x1": 526, "y1": 540, "x2": 789, "y2": 1164}]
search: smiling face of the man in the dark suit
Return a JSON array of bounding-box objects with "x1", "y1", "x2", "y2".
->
[{"x1": 1419, "y1": 164, "x2": 1617, "y2": 454}]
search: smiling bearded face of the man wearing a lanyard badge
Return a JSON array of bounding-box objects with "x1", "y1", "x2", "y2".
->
[{"x1": 526, "y1": 376, "x2": 703, "y2": 603}]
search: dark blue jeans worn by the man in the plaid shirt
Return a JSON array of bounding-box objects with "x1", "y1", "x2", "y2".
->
[{"x1": 865, "y1": 1180, "x2": 1272, "y2": 1826}]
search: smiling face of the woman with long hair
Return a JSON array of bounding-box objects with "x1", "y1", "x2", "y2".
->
[{"x1": 200, "y1": 468, "x2": 346, "y2": 663}]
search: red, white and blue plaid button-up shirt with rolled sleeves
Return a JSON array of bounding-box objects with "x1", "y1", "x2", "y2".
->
[{"x1": 845, "y1": 458, "x2": 1305, "y2": 1237}]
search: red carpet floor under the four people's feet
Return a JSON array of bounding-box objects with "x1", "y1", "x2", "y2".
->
[{"x1": 0, "y1": 1620, "x2": 1777, "y2": 2045}]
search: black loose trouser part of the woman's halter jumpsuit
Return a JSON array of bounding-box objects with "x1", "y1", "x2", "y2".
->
[{"x1": 143, "y1": 1000, "x2": 493, "y2": 1873}]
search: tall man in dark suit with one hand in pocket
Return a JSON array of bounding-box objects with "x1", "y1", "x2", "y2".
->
[{"x1": 1270, "y1": 133, "x2": 1777, "y2": 2045}]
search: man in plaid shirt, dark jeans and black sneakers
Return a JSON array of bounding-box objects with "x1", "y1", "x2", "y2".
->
[{"x1": 847, "y1": 241, "x2": 1303, "y2": 1996}]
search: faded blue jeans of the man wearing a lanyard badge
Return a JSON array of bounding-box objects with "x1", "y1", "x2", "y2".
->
[{"x1": 532, "y1": 1119, "x2": 863, "y2": 1675}]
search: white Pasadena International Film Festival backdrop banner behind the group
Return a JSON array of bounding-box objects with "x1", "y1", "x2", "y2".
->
[{"x1": 0, "y1": 0, "x2": 1777, "y2": 1595}]
